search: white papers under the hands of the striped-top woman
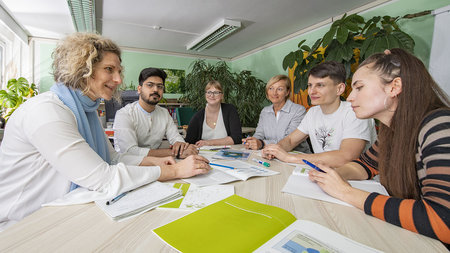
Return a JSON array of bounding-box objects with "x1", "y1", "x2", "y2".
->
[{"x1": 281, "y1": 165, "x2": 389, "y2": 206}]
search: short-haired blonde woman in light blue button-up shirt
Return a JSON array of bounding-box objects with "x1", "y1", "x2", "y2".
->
[{"x1": 243, "y1": 75, "x2": 311, "y2": 153}]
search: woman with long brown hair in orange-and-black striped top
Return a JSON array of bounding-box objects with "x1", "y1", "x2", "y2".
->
[{"x1": 310, "y1": 49, "x2": 450, "y2": 246}]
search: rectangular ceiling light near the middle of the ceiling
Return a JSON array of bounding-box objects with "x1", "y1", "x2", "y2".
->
[{"x1": 186, "y1": 19, "x2": 241, "y2": 51}]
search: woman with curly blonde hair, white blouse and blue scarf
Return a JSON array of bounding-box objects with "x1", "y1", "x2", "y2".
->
[{"x1": 0, "y1": 33, "x2": 210, "y2": 230}]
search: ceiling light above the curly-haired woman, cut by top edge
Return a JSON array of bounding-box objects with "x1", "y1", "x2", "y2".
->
[{"x1": 67, "y1": 0, "x2": 97, "y2": 32}]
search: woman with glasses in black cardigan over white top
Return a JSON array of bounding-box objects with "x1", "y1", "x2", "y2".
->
[{"x1": 185, "y1": 81, "x2": 242, "y2": 147}]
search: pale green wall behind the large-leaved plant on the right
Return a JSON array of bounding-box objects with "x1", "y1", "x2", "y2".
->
[{"x1": 231, "y1": 0, "x2": 450, "y2": 81}]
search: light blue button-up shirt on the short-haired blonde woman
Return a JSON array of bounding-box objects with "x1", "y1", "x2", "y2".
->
[{"x1": 253, "y1": 99, "x2": 310, "y2": 153}]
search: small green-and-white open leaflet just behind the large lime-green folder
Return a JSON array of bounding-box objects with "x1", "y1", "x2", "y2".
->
[{"x1": 158, "y1": 183, "x2": 234, "y2": 210}]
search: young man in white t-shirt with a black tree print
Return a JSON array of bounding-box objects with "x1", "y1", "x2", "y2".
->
[{"x1": 262, "y1": 61, "x2": 376, "y2": 167}]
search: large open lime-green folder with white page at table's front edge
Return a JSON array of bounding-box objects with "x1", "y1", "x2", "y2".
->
[{"x1": 153, "y1": 195, "x2": 377, "y2": 253}]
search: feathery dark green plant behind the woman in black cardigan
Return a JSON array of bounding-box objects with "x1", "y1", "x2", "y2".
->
[{"x1": 180, "y1": 59, "x2": 266, "y2": 127}]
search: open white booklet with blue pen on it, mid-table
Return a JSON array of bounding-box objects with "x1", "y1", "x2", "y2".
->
[{"x1": 183, "y1": 160, "x2": 279, "y2": 186}]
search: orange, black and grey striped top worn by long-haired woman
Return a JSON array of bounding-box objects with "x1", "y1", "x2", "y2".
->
[{"x1": 354, "y1": 110, "x2": 450, "y2": 245}]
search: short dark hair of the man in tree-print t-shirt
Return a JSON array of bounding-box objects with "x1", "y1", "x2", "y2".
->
[{"x1": 308, "y1": 61, "x2": 347, "y2": 84}]
